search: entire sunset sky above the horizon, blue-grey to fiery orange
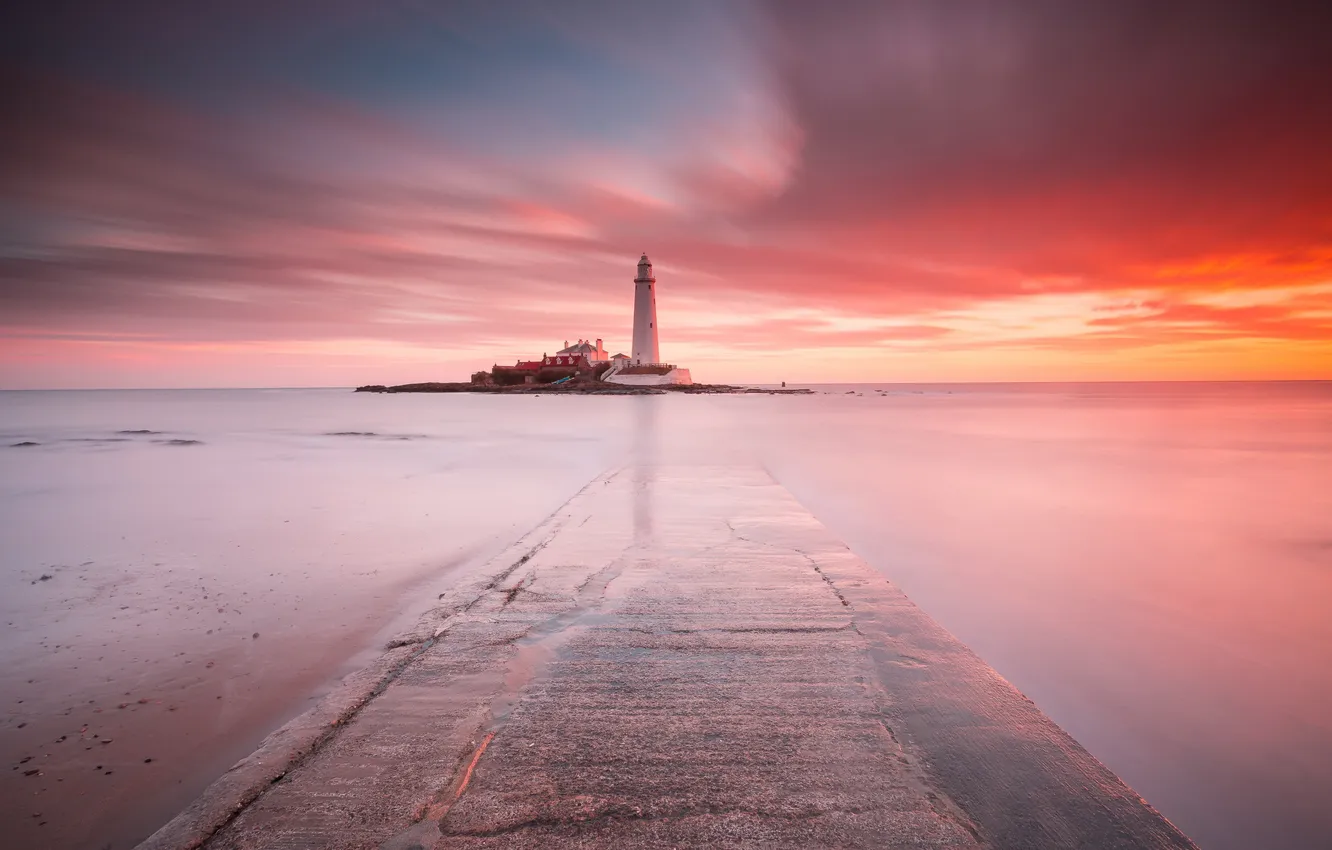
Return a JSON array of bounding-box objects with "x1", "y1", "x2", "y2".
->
[{"x1": 0, "y1": 0, "x2": 1332, "y2": 389}]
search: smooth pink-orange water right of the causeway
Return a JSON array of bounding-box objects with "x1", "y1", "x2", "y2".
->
[{"x1": 762, "y1": 384, "x2": 1332, "y2": 850}]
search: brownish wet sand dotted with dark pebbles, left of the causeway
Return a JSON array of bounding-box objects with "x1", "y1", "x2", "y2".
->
[{"x1": 0, "y1": 554, "x2": 482, "y2": 849}]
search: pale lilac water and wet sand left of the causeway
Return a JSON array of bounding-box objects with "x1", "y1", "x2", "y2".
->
[{"x1": 0, "y1": 390, "x2": 618, "y2": 850}]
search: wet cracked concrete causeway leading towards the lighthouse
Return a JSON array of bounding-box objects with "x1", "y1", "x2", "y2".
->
[{"x1": 141, "y1": 466, "x2": 1193, "y2": 850}]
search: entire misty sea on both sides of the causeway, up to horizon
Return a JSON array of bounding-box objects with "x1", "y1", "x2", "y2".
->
[{"x1": 0, "y1": 384, "x2": 1332, "y2": 850}]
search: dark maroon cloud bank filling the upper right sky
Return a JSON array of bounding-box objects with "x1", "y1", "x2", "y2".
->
[{"x1": 769, "y1": 0, "x2": 1332, "y2": 272}]
